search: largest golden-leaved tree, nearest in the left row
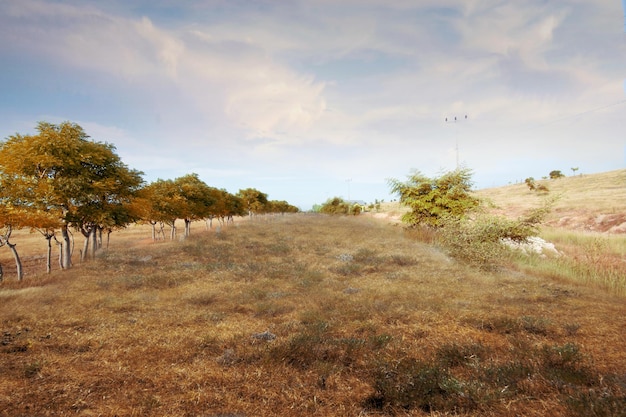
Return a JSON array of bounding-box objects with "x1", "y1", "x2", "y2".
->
[{"x1": 0, "y1": 122, "x2": 143, "y2": 269}]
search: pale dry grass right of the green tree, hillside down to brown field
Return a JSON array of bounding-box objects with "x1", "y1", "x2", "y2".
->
[{"x1": 470, "y1": 170, "x2": 626, "y2": 295}]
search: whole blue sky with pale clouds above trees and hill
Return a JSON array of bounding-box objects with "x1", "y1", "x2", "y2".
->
[{"x1": 0, "y1": 0, "x2": 626, "y2": 210}]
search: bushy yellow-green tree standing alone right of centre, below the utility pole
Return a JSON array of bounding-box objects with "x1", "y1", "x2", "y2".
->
[{"x1": 389, "y1": 168, "x2": 479, "y2": 227}]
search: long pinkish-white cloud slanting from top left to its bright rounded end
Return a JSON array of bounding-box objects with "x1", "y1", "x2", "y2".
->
[{"x1": 0, "y1": 0, "x2": 325, "y2": 144}]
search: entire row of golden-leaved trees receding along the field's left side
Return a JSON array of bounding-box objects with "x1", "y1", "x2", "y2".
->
[{"x1": 0, "y1": 122, "x2": 298, "y2": 281}]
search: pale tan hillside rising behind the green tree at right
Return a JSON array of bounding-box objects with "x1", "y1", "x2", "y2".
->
[{"x1": 476, "y1": 169, "x2": 626, "y2": 233}]
